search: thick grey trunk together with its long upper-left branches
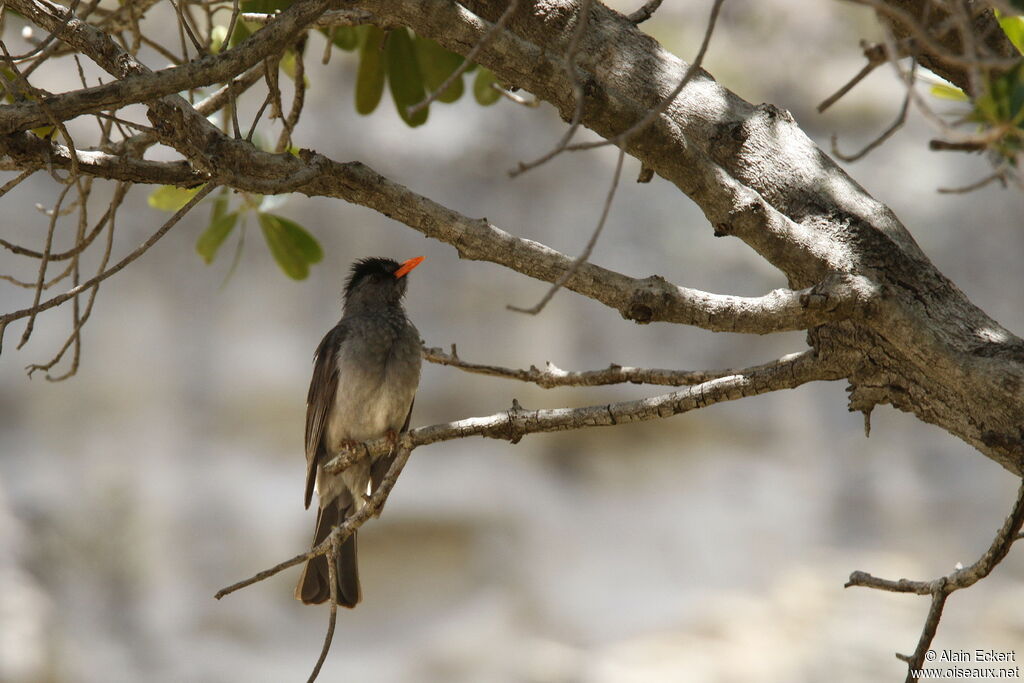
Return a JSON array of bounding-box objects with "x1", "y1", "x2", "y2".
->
[{"x1": 0, "y1": 0, "x2": 1024, "y2": 474}]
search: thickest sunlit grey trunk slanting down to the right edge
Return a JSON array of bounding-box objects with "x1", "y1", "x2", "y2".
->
[{"x1": 358, "y1": 0, "x2": 1024, "y2": 474}]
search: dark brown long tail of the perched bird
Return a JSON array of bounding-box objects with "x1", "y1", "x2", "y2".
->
[{"x1": 295, "y1": 500, "x2": 362, "y2": 607}]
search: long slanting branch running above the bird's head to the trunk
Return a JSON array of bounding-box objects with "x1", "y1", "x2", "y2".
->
[{"x1": 0, "y1": 132, "x2": 877, "y2": 334}]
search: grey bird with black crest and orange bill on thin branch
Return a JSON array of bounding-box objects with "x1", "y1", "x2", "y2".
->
[{"x1": 295, "y1": 256, "x2": 425, "y2": 607}]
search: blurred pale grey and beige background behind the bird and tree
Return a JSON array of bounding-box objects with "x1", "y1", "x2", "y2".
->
[{"x1": 0, "y1": 0, "x2": 1024, "y2": 683}]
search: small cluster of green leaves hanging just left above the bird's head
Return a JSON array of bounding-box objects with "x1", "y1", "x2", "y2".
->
[{"x1": 148, "y1": 185, "x2": 324, "y2": 280}]
